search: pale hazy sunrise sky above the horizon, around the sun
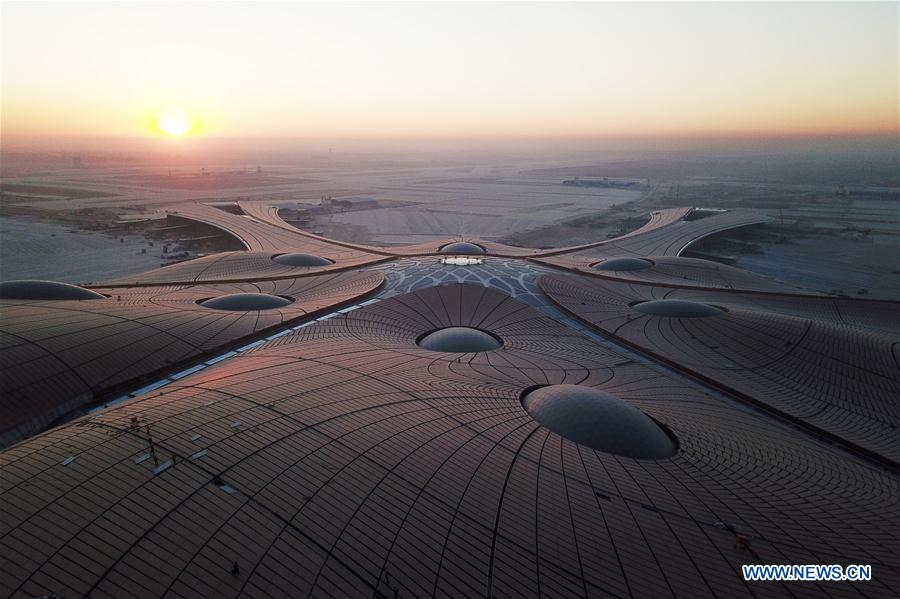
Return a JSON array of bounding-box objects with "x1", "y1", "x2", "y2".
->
[{"x1": 0, "y1": 2, "x2": 900, "y2": 140}]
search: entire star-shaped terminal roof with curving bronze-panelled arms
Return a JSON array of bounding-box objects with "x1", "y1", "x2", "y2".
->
[{"x1": 0, "y1": 202, "x2": 900, "y2": 598}]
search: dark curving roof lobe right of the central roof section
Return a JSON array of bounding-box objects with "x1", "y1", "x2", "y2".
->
[{"x1": 540, "y1": 275, "x2": 900, "y2": 465}]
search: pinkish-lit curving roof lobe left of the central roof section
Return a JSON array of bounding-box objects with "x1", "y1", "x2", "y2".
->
[{"x1": 0, "y1": 272, "x2": 383, "y2": 445}]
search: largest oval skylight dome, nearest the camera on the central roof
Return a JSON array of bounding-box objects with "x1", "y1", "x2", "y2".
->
[{"x1": 522, "y1": 385, "x2": 677, "y2": 459}]
